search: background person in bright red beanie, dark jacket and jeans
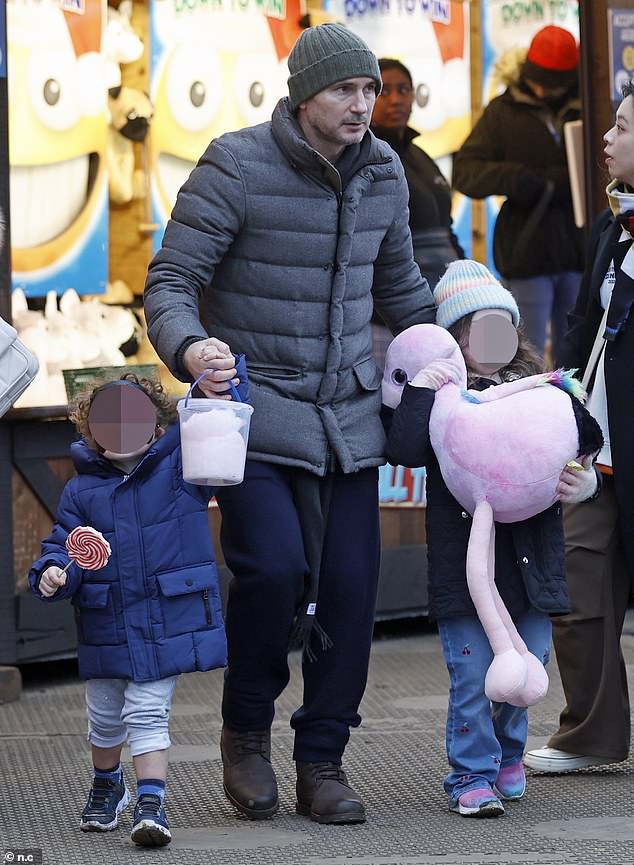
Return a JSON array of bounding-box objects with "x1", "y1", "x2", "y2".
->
[{"x1": 453, "y1": 25, "x2": 584, "y2": 360}]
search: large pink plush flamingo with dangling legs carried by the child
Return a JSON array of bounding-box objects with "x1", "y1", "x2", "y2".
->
[{"x1": 383, "y1": 324, "x2": 596, "y2": 706}]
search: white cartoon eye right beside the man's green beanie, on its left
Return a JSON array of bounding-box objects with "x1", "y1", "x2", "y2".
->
[{"x1": 234, "y1": 54, "x2": 288, "y2": 125}]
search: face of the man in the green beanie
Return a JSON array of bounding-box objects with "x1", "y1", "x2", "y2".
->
[{"x1": 297, "y1": 78, "x2": 376, "y2": 162}]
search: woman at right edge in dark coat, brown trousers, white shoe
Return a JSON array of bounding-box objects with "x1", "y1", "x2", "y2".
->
[{"x1": 524, "y1": 81, "x2": 634, "y2": 772}]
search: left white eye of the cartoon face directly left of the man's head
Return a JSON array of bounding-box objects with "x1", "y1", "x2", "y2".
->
[{"x1": 167, "y1": 42, "x2": 223, "y2": 132}]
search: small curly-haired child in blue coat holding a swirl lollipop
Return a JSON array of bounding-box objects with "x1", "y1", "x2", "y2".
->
[{"x1": 29, "y1": 358, "x2": 248, "y2": 847}]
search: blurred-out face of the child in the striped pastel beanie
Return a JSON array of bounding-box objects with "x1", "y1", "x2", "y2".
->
[{"x1": 463, "y1": 309, "x2": 518, "y2": 375}]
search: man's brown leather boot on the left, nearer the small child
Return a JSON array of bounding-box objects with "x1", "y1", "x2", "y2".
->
[{"x1": 220, "y1": 726, "x2": 279, "y2": 820}]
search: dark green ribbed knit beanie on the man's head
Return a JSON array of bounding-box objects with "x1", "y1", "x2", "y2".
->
[{"x1": 288, "y1": 24, "x2": 381, "y2": 111}]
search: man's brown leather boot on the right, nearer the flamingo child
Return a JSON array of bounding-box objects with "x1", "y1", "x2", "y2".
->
[{"x1": 296, "y1": 760, "x2": 365, "y2": 823}]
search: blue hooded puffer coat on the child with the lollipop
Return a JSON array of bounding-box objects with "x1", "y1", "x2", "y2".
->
[{"x1": 29, "y1": 425, "x2": 226, "y2": 682}]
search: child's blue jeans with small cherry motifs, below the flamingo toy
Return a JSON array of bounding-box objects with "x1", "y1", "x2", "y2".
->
[{"x1": 438, "y1": 607, "x2": 551, "y2": 804}]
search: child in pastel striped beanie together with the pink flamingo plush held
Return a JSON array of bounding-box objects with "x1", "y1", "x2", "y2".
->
[{"x1": 383, "y1": 260, "x2": 602, "y2": 817}]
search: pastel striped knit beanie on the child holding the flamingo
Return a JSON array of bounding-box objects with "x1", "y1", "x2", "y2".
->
[{"x1": 434, "y1": 258, "x2": 520, "y2": 328}]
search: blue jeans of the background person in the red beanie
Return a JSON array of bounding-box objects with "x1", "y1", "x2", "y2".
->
[{"x1": 504, "y1": 270, "x2": 581, "y2": 359}]
